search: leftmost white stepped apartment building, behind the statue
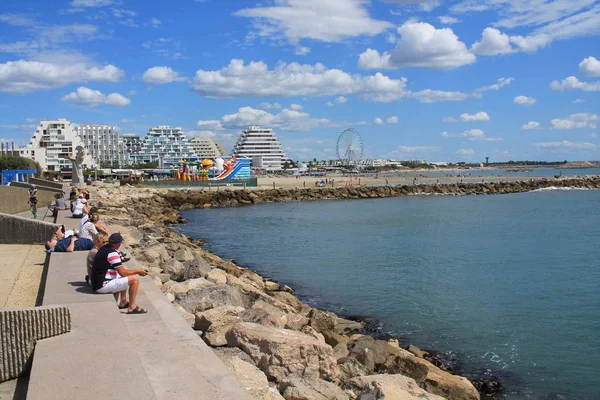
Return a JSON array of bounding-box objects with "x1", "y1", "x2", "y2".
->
[{"x1": 15, "y1": 118, "x2": 96, "y2": 171}]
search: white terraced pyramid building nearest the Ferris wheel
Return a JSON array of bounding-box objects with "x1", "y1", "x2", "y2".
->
[{"x1": 233, "y1": 126, "x2": 287, "y2": 170}]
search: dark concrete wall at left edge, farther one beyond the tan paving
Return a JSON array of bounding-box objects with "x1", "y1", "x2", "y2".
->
[{"x1": 0, "y1": 213, "x2": 58, "y2": 244}]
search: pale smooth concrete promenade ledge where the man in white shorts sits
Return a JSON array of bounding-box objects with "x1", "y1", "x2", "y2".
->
[{"x1": 27, "y1": 211, "x2": 253, "y2": 400}]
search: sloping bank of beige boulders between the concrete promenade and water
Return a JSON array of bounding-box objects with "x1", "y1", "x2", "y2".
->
[{"x1": 92, "y1": 188, "x2": 480, "y2": 400}]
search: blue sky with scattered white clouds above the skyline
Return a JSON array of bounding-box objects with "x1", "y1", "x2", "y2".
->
[{"x1": 0, "y1": 0, "x2": 600, "y2": 161}]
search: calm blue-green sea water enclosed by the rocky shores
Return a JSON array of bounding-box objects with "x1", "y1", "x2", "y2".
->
[{"x1": 183, "y1": 190, "x2": 600, "y2": 400}]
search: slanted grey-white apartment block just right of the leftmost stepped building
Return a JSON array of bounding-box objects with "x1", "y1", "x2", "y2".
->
[{"x1": 75, "y1": 124, "x2": 129, "y2": 168}]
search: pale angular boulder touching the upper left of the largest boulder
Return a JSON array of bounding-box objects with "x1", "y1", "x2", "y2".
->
[{"x1": 194, "y1": 306, "x2": 244, "y2": 347}]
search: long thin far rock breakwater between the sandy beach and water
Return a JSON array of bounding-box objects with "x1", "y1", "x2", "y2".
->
[{"x1": 157, "y1": 176, "x2": 600, "y2": 210}]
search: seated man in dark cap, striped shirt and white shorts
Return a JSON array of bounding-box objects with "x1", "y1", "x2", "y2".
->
[{"x1": 91, "y1": 233, "x2": 148, "y2": 314}]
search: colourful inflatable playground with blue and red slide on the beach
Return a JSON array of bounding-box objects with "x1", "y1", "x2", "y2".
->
[{"x1": 175, "y1": 157, "x2": 251, "y2": 182}]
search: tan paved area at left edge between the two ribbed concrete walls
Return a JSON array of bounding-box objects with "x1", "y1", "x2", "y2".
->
[{"x1": 0, "y1": 244, "x2": 46, "y2": 308}]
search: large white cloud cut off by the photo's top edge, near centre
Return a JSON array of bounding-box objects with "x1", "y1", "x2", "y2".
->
[{"x1": 234, "y1": 0, "x2": 392, "y2": 45}]
